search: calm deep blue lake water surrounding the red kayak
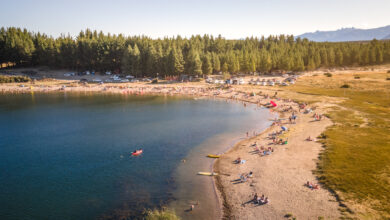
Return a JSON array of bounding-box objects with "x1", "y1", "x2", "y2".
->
[{"x1": 0, "y1": 94, "x2": 268, "y2": 219}]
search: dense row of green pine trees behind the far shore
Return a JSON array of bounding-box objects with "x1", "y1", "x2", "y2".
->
[{"x1": 0, "y1": 27, "x2": 390, "y2": 76}]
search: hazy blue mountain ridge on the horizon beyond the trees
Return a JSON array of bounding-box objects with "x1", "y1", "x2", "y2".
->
[{"x1": 297, "y1": 25, "x2": 390, "y2": 42}]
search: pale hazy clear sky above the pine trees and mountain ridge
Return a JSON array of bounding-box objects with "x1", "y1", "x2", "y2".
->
[{"x1": 0, "y1": 0, "x2": 390, "y2": 38}]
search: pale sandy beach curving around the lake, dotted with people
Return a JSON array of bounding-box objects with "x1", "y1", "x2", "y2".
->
[{"x1": 0, "y1": 81, "x2": 340, "y2": 219}]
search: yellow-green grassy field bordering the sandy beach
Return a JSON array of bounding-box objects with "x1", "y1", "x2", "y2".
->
[{"x1": 285, "y1": 72, "x2": 390, "y2": 219}]
